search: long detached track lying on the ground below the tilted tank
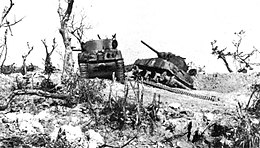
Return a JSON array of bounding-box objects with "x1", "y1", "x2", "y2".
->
[{"x1": 143, "y1": 81, "x2": 220, "y2": 101}]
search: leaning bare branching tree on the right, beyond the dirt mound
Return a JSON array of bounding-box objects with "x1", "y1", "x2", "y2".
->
[{"x1": 211, "y1": 30, "x2": 260, "y2": 72}]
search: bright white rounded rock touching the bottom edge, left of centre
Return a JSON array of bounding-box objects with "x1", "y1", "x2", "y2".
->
[{"x1": 87, "y1": 129, "x2": 104, "y2": 148}]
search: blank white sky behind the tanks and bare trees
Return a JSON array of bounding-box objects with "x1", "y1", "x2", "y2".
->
[{"x1": 0, "y1": 0, "x2": 260, "y2": 72}]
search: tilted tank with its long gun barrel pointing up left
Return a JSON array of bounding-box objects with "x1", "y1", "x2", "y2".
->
[{"x1": 133, "y1": 41, "x2": 194, "y2": 89}]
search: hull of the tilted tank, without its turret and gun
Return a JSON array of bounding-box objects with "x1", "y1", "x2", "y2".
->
[{"x1": 134, "y1": 58, "x2": 194, "y2": 89}]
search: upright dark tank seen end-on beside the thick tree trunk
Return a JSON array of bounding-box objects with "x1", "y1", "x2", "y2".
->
[{"x1": 78, "y1": 35, "x2": 124, "y2": 82}]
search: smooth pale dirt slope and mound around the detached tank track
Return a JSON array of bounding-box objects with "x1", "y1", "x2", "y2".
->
[{"x1": 115, "y1": 73, "x2": 260, "y2": 111}]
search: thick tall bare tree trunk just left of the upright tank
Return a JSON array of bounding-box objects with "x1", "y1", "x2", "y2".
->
[{"x1": 58, "y1": 0, "x2": 74, "y2": 78}]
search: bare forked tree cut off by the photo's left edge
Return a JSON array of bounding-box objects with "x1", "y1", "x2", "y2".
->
[{"x1": 0, "y1": 0, "x2": 23, "y2": 72}]
